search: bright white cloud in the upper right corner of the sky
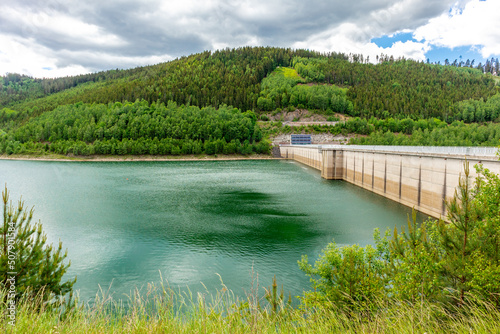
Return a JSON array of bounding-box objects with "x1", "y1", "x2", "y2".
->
[{"x1": 414, "y1": 0, "x2": 500, "y2": 58}]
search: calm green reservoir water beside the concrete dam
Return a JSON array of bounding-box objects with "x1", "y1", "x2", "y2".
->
[{"x1": 0, "y1": 160, "x2": 426, "y2": 300}]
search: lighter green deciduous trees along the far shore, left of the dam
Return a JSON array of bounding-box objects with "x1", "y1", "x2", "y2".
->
[{"x1": 0, "y1": 101, "x2": 270, "y2": 156}]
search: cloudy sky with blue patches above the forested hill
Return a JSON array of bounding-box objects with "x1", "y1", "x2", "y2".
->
[{"x1": 0, "y1": 0, "x2": 500, "y2": 77}]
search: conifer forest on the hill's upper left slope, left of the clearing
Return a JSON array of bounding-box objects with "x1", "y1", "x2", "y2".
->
[{"x1": 0, "y1": 47, "x2": 319, "y2": 126}]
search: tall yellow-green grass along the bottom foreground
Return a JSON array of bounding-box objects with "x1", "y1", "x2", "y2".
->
[{"x1": 0, "y1": 284, "x2": 500, "y2": 334}]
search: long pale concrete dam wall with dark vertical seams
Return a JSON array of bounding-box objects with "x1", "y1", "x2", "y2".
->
[{"x1": 280, "y1": 145, "x2": 500, "y2": 218}]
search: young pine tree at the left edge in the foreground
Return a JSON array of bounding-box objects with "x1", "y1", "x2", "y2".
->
[{"x1": 0, "y1": 187, "x2": 76, "y2": 303}]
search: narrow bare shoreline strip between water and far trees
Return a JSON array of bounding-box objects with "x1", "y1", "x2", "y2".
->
[{"x1": 0, "y1": 154, "x2": 281, "y2": 162}]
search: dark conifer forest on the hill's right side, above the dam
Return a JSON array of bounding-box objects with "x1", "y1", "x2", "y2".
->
[{"x1": 293, "y1": 58, "x2": 498, "y2": 122}]
